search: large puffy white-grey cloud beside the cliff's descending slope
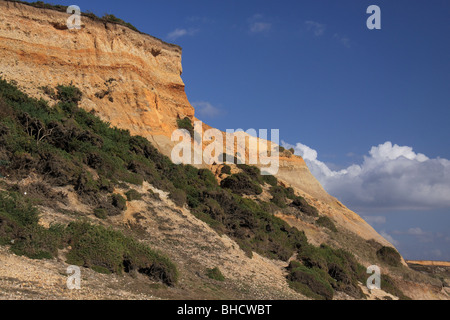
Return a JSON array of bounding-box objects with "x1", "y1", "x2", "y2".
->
[{"x1": 283, "y1": 142, "x2": 450, "y2": 211}]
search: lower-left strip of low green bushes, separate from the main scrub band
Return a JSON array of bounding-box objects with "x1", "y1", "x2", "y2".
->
[{"x1": 0, "y1": 191, "x2": 178, "y2": 285}]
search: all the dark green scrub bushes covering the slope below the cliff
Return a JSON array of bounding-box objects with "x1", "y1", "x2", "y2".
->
[{"x1": 0, "y1": 80, "x2": 410, "y2": 299}]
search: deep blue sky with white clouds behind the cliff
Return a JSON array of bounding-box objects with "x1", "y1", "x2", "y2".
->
[{"x1": 26, "y1": 0, "x2": 450, "y2": 260}]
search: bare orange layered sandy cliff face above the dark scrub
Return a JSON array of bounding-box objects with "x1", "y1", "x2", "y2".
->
[{"x1": 0, "y1": 1, "x2": 389, "y2": 250}]
